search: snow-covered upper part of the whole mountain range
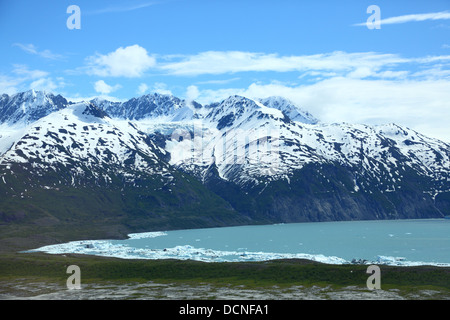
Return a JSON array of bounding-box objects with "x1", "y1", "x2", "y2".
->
[{"x1": 0, "y1": 91, "x2": 450, "y2": 195}]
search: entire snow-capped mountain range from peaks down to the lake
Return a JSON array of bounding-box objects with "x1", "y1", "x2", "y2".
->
[{"x1": 0, "y1": 90, "x2": 450, "y2": 235}]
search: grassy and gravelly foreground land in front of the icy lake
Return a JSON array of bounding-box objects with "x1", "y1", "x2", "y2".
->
[{"x1": 0, "y1": 219, "x2": 450, "y2": 300}]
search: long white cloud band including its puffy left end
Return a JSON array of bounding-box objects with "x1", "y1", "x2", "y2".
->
[{"x1": 81, "y1": 45, "x2": 450, "y2": 85}]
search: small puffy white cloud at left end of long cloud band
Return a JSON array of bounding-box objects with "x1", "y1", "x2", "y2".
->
[{"x1": 86, "y1": 45, "x2": 156, "y2": 78}]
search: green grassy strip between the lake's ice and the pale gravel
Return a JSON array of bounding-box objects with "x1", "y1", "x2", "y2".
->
[{"x1": 0, "y1": 222, "x2": 450, "y2": 299}]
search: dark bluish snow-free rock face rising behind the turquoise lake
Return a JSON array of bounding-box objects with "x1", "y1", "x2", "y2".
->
[{"x1": 206, "y1": 164, "x2": 449, "y2": 222}]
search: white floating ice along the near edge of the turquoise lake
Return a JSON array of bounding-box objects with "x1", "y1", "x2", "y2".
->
[{"x1": 23, "y1": 222, "x2": 450, "y2": 267}]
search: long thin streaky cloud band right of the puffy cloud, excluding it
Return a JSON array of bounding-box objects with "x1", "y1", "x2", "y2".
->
[{"x1": 154, "y1": 51, "x2": 450, "y2": 84}]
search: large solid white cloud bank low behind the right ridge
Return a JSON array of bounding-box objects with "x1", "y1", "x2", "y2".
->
[{"x1": 197, "y1": 77, "x2": 450, "y2": 142}]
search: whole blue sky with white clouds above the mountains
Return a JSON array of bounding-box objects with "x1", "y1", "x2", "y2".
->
[{"x1": 0, "y1": 0, "x2": 450, "y2": 142}]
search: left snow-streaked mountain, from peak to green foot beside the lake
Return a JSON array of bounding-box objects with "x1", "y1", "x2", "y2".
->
[{"x1": 0, "y1": 95, "x2": 243, "y2": 230}]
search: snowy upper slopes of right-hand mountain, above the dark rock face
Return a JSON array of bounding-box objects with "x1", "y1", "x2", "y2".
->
[{"x1": 155, "y1": 96, "x2": 450, "y2": 191}]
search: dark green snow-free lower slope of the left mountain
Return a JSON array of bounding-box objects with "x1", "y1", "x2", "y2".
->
[{"x1": 0, "y1": 161, "x2": 249, "y2": 241}]
